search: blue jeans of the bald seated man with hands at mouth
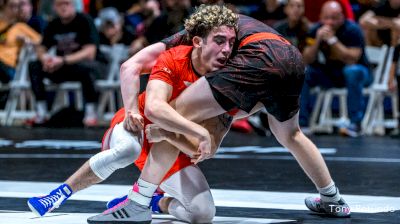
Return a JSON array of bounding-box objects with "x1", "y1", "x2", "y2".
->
[{"x1": 300, "y1": 64, "x2": 373, "y2": 126}]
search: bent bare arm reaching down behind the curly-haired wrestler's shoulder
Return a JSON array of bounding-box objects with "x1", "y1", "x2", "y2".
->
[{"x1": 120, "y1": 42, "x2": 166, "y2": 131}]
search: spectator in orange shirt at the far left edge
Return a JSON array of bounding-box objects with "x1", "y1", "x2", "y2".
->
[{"x1": 0, "y1": 0, "x2": 41, "y2": 83}]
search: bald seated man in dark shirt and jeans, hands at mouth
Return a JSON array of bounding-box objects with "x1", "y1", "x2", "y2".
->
[{"x1": 300, "y1": 1, "x2": 372, "y2": 136}]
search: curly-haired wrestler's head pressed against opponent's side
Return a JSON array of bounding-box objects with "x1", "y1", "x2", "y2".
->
[{"x1": 185, "y1": 5, "x2": 238, "y2": 74}]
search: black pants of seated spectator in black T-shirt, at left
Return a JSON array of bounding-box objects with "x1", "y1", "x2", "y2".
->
[{"x1": 29, "y1": 61, "x2": 100, "y2": 103}]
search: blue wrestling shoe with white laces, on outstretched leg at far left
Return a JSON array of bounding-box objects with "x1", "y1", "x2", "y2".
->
[{"x1": 28, "y1": 184, "x2": 72, "y2": 216}]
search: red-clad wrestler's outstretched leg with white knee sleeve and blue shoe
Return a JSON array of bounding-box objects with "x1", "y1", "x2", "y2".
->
[{"x1": 28, "y1": 123, "x2": 141, "y2": 216}]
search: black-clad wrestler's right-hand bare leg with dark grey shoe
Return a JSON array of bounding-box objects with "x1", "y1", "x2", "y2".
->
[{"x1": 268, "y1": 113, "x2": 350, "y2": 217}]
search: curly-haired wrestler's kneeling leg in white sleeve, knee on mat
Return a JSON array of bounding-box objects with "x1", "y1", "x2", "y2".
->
[{"x1": 160, "y1": 165, "x2": 215, "y2": 223}]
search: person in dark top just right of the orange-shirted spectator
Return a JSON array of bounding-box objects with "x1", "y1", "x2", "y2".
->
[{"x1": 18, "y1": 0, "x2": 46, "y2": 34}]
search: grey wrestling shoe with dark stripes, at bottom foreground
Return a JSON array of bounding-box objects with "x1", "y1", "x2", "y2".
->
[{"x1": 87, "y1": 198, "x2": 152, "y2": 224}]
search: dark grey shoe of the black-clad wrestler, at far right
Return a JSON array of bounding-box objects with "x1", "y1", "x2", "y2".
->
[{"x1": 304, "y1": 197, "x2": 351, "y2": 218}]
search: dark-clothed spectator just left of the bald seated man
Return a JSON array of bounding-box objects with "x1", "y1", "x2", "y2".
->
[{"x1": 274, "y1": 0, "x2": 310, "y2": 51}]
